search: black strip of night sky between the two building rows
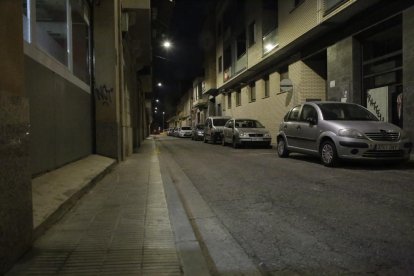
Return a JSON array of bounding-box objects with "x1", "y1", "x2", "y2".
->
[{"x1": 153, "y1": 0, "x2": 212, "y2": 120}]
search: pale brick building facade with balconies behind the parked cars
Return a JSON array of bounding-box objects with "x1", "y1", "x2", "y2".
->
[{"x1": 199, "y1": 0, "x2": 414, "y2": 148}]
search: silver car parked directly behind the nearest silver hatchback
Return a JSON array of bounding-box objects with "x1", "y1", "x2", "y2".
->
[{"x1": 222, "y1": 119, "x2": 272, "y2": 148}]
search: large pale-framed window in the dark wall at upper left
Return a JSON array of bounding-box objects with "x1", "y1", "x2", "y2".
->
[{"x1": 22, "y1": 0, "x2": 90, "y2": 84}]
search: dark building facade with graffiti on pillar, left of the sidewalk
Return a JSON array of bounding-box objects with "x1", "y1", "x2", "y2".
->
[{"x1": 0, "y1": 0, "x2": 152, "y2": 274}]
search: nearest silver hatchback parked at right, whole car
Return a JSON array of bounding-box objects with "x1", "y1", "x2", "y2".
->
[{"x1": 277, "y1": 102, "x2": 412, "y2": 167}]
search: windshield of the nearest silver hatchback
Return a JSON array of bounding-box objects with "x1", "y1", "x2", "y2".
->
[{"x1": 318, "y1": 103, "x2": 378, "y2": 121}]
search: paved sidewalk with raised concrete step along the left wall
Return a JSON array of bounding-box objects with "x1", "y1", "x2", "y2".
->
[{"x1": 7, "y1": 139, "x2": 209, "y2": 275}]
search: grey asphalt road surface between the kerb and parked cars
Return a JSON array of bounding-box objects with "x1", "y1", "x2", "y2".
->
[{"x1": 157, "y1": 136, "x2": 414, "y2": 275}]
